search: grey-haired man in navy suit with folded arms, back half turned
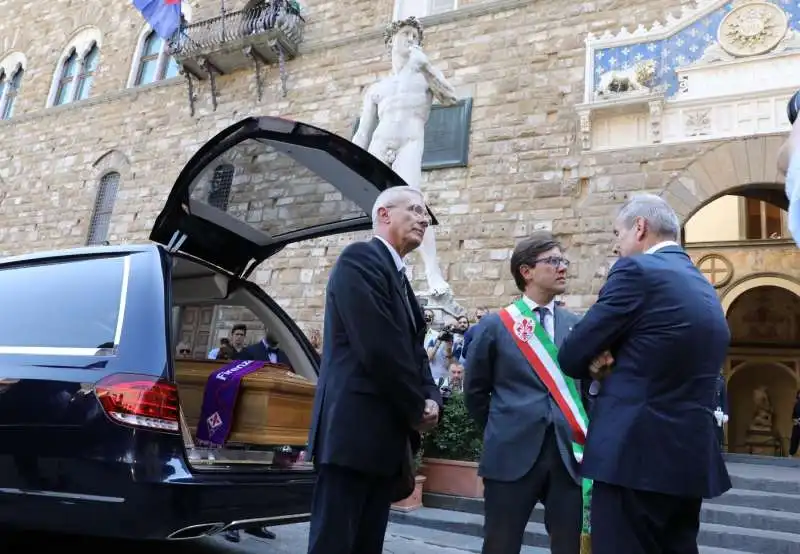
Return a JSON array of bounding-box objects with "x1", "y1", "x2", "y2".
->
[{"x1": 558, "y1": 194, "x2": 731, "y2": 554}]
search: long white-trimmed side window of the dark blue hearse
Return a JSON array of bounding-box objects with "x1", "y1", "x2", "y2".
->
[{"x1": 0, "y1": 253, "x2": 130, "y2": 354}]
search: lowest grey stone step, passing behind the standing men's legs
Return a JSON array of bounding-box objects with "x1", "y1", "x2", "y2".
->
[{"x1": 390, "y1": 508, "x2": 800, "y2": 554}]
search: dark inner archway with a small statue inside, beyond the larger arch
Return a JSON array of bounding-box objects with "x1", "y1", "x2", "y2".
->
[{"x1": 723, "y1": 284, "x2": 800, "y2": 455}]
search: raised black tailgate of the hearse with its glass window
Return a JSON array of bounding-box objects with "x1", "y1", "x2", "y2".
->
[{"x1": 150, "y1": 117, "x2": 435, "y2": 277}]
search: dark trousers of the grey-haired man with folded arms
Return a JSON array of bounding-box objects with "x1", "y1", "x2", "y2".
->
[{"x1": 592, "y1": 481, "x2": 702, "y2": 554}]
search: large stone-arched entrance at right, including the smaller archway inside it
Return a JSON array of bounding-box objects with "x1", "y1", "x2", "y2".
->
[{"x1": 680, "y1": 137, "x2": 800, "y2": 455}]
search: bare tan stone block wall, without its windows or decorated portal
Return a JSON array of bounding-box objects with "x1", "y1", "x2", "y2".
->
[{"x1": 0, "y1": 0, "x2": 792, "y2": 327}]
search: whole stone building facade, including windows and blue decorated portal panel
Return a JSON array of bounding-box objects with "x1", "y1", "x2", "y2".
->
[{"x1": 0, "y1": 0, "x2": 800, "y2": 448}]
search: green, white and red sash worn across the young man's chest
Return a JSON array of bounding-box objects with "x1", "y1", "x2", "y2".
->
[{"x1": 500, "y1": 299, "x2": 592, "y2": 554}]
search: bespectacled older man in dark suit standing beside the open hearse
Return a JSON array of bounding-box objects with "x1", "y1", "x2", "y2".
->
[{"x1": 308, "y1": 187, "x2": 442, "y2": 554}]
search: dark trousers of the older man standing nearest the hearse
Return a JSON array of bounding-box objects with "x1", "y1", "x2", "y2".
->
[{"x1": 308, "y1": 464, "x2": 393, "y2": 554}]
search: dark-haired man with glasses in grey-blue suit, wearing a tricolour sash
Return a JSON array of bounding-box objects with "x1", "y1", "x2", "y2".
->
[{"x1": 464, "y1": 232, "x2": 585, "y2": 554}]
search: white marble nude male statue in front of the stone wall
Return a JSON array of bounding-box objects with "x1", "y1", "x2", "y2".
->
[{"x1": 353, "y1": 17, "x2": 456, "y2": 296}]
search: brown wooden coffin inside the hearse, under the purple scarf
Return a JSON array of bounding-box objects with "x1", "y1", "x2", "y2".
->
[{"x1": 175, "y1": 360, "x2": 316, "y2": 447}]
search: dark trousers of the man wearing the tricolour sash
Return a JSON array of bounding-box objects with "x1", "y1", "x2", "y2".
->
[{"x1": 482, "y1": 427, "x2": 580, "y2": 554}]
